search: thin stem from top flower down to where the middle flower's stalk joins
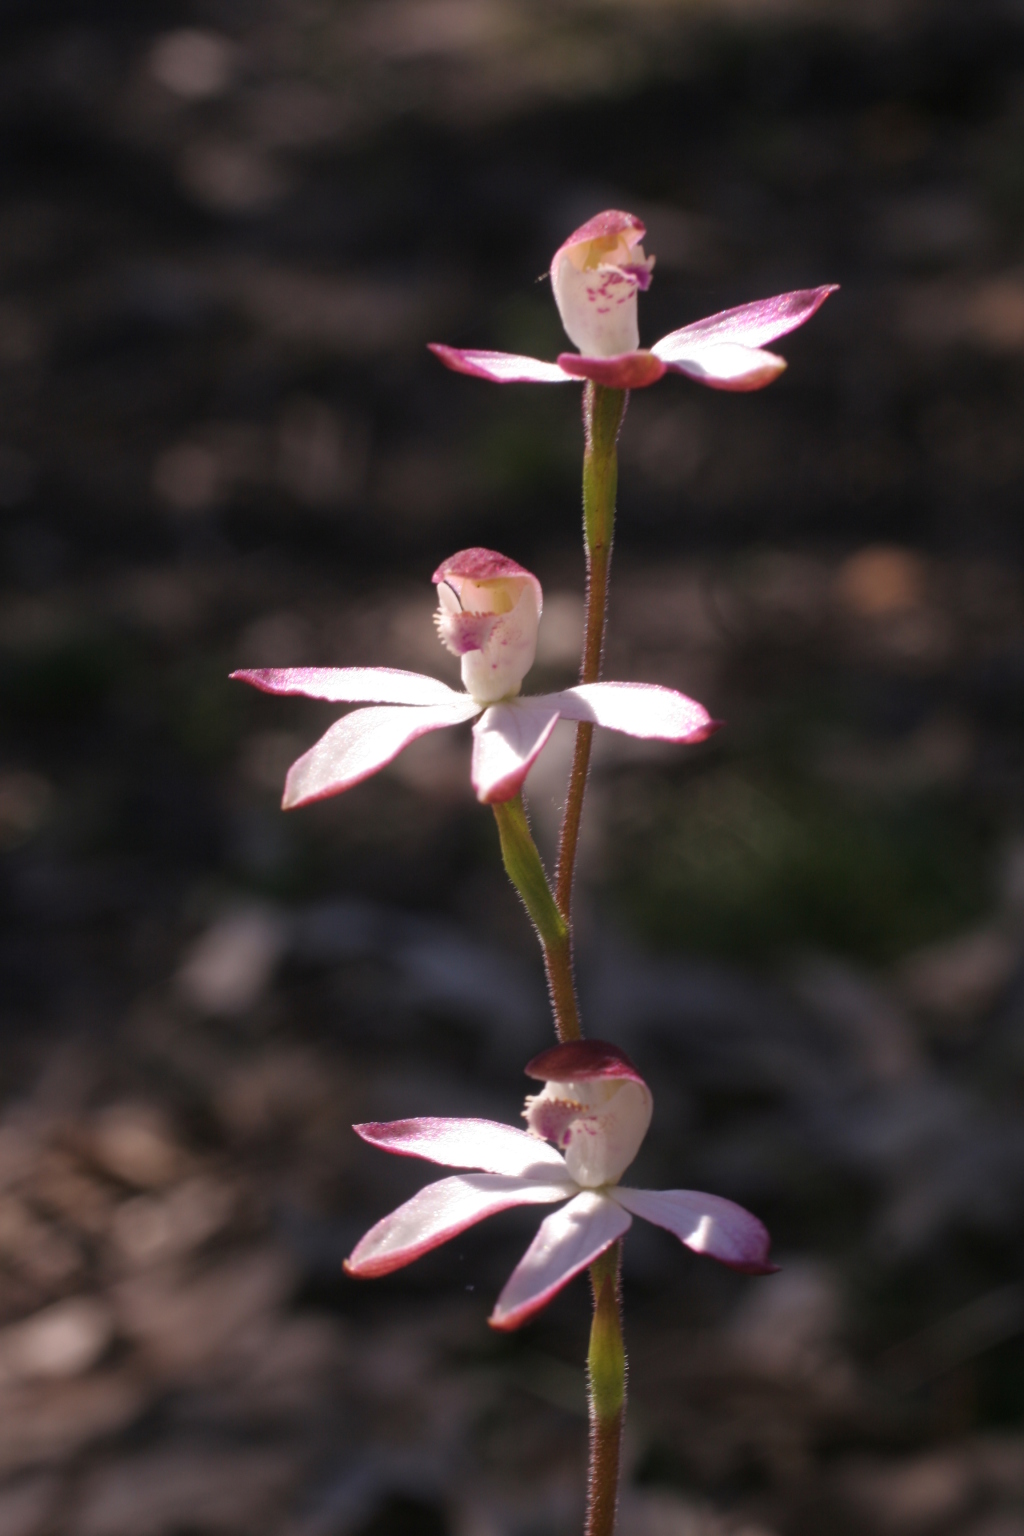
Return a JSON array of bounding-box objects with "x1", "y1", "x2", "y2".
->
[{"x1": 554, "y1": 382, "x2": 629, "y2": 925}]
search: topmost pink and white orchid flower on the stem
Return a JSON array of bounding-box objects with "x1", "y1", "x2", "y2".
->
[{"x1": 430, "y1": 209, "x2": 838, "y2": 390}]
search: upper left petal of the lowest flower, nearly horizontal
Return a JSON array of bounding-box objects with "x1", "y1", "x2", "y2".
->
[{"x1": 352, "y1": 1115, "x2": 571, "y2": 1184}]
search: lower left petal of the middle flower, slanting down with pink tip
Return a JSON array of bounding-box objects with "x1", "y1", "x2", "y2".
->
[{"x1": 282, "y1": 694, "x2": 481, "y2": 811}]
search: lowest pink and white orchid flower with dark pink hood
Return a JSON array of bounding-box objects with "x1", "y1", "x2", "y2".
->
[{"x1": 345, "y1": 1040, "x2": 777, "y2": 1330}]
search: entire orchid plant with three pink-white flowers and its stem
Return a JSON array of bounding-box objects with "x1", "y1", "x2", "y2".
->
[{"x1": 233, "y1": 209, "x2": 832, "y2": 1536}]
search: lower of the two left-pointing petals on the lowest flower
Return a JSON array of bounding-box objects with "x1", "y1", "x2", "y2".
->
[{"x1": 345, "y1": 1174, "x2": 568, "y2": 1279}]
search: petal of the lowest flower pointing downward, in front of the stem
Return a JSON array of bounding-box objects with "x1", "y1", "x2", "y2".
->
[{"x1": 488, "y1": 1190, "x2": 633, "y2": 1332}]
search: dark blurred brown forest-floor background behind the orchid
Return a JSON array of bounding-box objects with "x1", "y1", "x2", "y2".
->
[{"x1": 0, "y1": 0, "x2": 1024, "y2": 1536}]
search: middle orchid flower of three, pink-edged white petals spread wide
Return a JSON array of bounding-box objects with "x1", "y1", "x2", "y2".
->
[{"x1": 232, "y1": 548, "x2": 718, "y2": 809}]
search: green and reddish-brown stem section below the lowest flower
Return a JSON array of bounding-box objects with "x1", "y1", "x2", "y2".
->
[{"x1": 586, "y1": 1243, "x2": 626, "y2": 1536}]
